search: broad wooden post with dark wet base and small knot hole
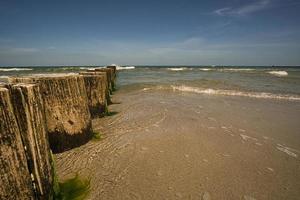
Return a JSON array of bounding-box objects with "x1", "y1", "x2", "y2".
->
[{"x1": 9, "y1": 75, "x2": 92, "y2": 153}]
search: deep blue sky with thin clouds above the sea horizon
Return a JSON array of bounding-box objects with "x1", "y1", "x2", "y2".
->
[{"x1": 0, "y1": 0, "x2": 300, "y2": 66}]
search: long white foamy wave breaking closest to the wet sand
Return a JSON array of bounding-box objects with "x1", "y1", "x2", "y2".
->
[{"x1": 171, "y1": 85, "x2": 300, "y2": 101}]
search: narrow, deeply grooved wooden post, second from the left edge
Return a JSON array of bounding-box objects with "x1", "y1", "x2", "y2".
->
[{"x1": 8, "y1": 83, "x2": 53, "y2": 199}]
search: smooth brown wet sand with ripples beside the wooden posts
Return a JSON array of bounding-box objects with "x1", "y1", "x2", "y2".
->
[{"x1": 56, "y1": 90, "x2": 300, "y2": 200}]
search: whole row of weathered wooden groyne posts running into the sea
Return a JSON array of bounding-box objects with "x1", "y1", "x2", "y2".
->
[{"x1": 0, "y1": 68, "x2": 116, "y2": 199}]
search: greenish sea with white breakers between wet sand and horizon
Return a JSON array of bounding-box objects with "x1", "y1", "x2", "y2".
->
[{"x1": 0, "y1": 66, "x2": 300, "y2": 101}]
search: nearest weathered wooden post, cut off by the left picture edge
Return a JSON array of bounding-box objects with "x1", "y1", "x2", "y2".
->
[{"x1": 0, "y1": 87, "x2": 34, "y2": 199}]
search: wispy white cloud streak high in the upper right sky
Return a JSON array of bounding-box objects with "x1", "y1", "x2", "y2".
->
[{"x1": 213, "y1": 0, "x2": 271, "y2": 16}]
